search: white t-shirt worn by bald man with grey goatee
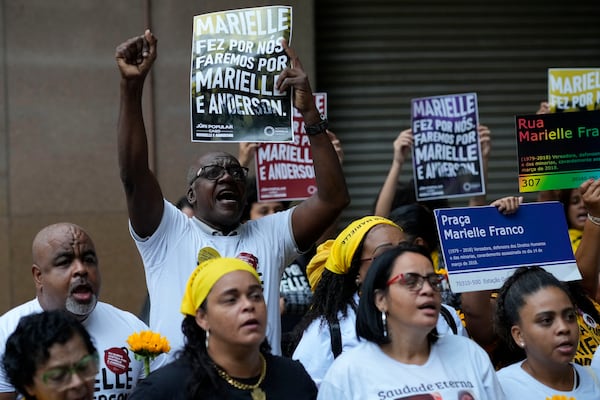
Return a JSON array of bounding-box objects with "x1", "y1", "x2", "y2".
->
[{"x1": 0, "y1": 298, "x2": 159, "y2": 400}]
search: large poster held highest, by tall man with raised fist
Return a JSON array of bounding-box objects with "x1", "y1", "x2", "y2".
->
[{"x1": 190, "y1": 6, "x2": 293, "y2": 142}]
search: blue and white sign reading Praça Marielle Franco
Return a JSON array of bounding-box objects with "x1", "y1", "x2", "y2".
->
[{"x1": 434, "y1": 202, "x2": 581, "y2": 293}]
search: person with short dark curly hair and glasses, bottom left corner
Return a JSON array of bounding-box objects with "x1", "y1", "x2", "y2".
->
[{"x1": 2, "y1": 310, "x2": 98, "y2": 400}]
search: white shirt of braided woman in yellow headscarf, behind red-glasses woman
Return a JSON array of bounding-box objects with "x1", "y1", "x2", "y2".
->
[{"x1": 292, "y1": 294, "x2": 467, "y2": 386}]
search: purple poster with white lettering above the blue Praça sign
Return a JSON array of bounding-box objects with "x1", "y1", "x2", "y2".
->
[{"x1": 411, "y1": 93, "x2": 485, "y2": 201}]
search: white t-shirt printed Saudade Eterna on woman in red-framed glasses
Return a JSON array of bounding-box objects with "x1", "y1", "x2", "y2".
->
[{"x1": 318, "y1": 335, "x2": 504, "y2": 400}]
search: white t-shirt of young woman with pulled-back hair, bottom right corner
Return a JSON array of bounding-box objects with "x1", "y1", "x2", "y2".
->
[{"x1": 498, "y1": 361, "x2": 600, "y2": 400}]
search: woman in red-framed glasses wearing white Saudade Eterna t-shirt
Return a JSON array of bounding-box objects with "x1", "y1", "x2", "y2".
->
[{"x1": 318, "y1": 244, "x2": 504, "y2": 400}]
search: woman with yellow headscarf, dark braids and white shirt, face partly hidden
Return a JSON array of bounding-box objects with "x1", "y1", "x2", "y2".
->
[{"x1": 292, "y1": 216, "x2": 405, "y2": 385}]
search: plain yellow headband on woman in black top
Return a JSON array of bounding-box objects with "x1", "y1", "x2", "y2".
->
[{"x1": 181, "y1": 258, "x2": 260, "y2": 316}]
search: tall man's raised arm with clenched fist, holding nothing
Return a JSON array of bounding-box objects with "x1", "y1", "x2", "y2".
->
[{"x1": 115, "y1": 30, "x2": 164, "y2": 237}]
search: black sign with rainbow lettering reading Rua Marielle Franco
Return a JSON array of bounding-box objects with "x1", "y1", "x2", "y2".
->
[{"x1": 516, "y1": 111, "x2": 600, "y2": 193}]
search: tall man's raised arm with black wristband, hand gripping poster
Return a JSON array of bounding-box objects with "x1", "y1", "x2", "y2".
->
[{"x1": 276, "y1": 42, "x2": 350, "y2": 250}]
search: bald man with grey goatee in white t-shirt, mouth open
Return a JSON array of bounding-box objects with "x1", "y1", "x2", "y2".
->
[{"x1": 0, "y1": 222, "x2": 163, "y2": 400}]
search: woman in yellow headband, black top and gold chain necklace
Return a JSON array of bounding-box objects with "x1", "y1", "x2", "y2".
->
[{"x1": 129, "y1": 258, "x2": 317, "y2": 400}]
